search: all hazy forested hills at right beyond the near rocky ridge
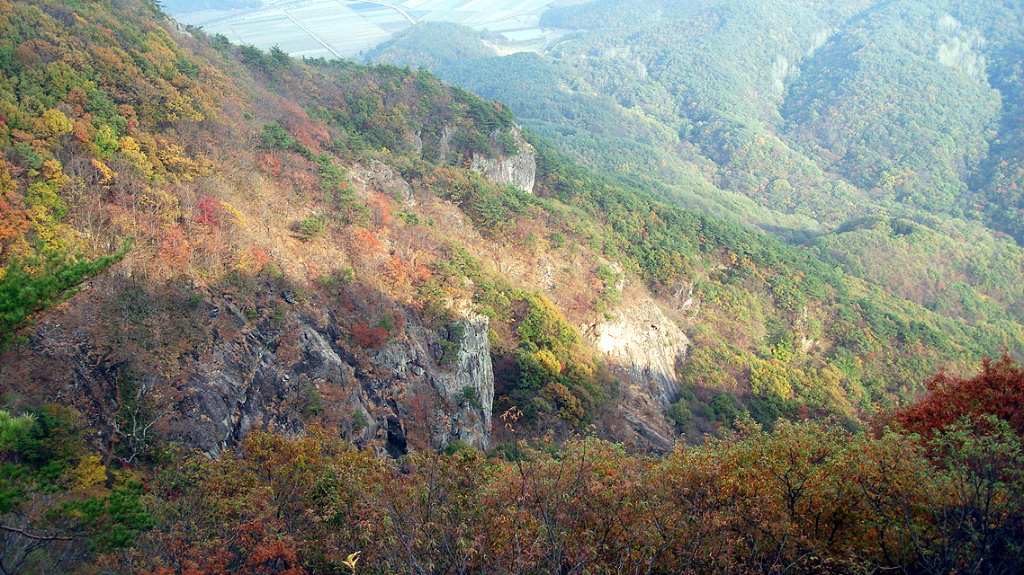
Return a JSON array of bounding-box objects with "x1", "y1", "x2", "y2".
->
[{"x1": 371, "y1": 0, "x2": 1024, "y2": 411}]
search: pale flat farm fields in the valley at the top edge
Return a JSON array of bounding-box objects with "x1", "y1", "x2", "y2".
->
[{"x1": 171, "y1": 0, "x2": 556, "y2": 59}]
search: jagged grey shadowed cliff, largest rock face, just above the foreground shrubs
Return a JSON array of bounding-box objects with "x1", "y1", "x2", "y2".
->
[{"x1": 186, "y1": 296, "x2": 494, "y2": 456}]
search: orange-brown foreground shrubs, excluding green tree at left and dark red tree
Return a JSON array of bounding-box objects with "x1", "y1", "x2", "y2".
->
[{"x1": 112, "y1": 415, "x2": 1024, "y2": 574}]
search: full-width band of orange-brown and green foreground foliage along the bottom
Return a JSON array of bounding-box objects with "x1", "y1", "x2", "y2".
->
[{"x1": 6, "y1": 359, "x2": 1024, "y2": 575}]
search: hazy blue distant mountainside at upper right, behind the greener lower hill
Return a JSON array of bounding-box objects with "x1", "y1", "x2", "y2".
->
[{"x1": 405, "y1": 0, "x2": 1022, "y2": 229}]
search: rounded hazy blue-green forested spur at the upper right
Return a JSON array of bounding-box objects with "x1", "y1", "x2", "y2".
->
[{"x1": 782, "y1": 2, "x2": 999, "y2": 215}]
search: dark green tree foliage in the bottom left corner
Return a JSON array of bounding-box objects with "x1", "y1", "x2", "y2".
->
[{"x1": 0, "y1": 405, "x2": 151, "y2": 573}]
